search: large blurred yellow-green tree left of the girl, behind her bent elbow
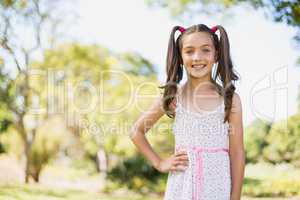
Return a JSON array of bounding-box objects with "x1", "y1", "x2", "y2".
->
[{"x1": 32, "y1": 43, "x2": 164, "y2": 181}]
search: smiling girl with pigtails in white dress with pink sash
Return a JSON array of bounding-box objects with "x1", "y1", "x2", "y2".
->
[{"x1": 130, "y1": 24, "x2": 245, "y2": 200}]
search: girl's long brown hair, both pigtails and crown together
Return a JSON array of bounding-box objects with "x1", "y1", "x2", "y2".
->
[{"x1": 160, "y1": 24, "x2": 239, "y2": 122}]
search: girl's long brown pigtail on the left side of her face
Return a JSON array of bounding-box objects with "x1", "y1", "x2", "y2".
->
[{"x1": 160, "y1": 26, "x2": 183, "y2": 118}]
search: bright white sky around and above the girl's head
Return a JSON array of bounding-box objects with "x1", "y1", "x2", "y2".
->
[{"x1": 73, "y1": 0, "x2": 300, "y2": 125}]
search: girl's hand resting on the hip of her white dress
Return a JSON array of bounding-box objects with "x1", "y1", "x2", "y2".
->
[{"x1": 157, "y1": 150, "x2": 189, "y2": 173}]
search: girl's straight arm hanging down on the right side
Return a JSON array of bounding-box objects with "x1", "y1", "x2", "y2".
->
[{"x1": 229, "y1": 93, "x2": 245, "y2": 200}]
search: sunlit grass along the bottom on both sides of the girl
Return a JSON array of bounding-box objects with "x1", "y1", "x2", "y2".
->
[{"x1": 0, "y1": 155, "x2": 300, "y2": 200}]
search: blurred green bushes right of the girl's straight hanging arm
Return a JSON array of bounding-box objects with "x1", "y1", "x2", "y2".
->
[{"x1": 245, "y1": 114, "x2": 300, "y2": 166}]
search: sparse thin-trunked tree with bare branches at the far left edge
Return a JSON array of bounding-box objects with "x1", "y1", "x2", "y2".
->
[{"x1": 0, "y1": 0, "x2": 74, "y2": 182}]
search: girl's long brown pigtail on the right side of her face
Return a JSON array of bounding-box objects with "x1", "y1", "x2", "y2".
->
[{"x1": 215, "y1": 25, "x2": 239, "y2": 122}]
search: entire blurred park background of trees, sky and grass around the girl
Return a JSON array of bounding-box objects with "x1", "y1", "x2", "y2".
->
[{"x1": 0, "y1": 0, "x2": 300, "y2": 200}]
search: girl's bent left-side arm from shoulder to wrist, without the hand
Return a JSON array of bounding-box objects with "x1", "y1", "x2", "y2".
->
[{"x1": 130, "y1": 96, "x2": 164, "y2": 169}]
